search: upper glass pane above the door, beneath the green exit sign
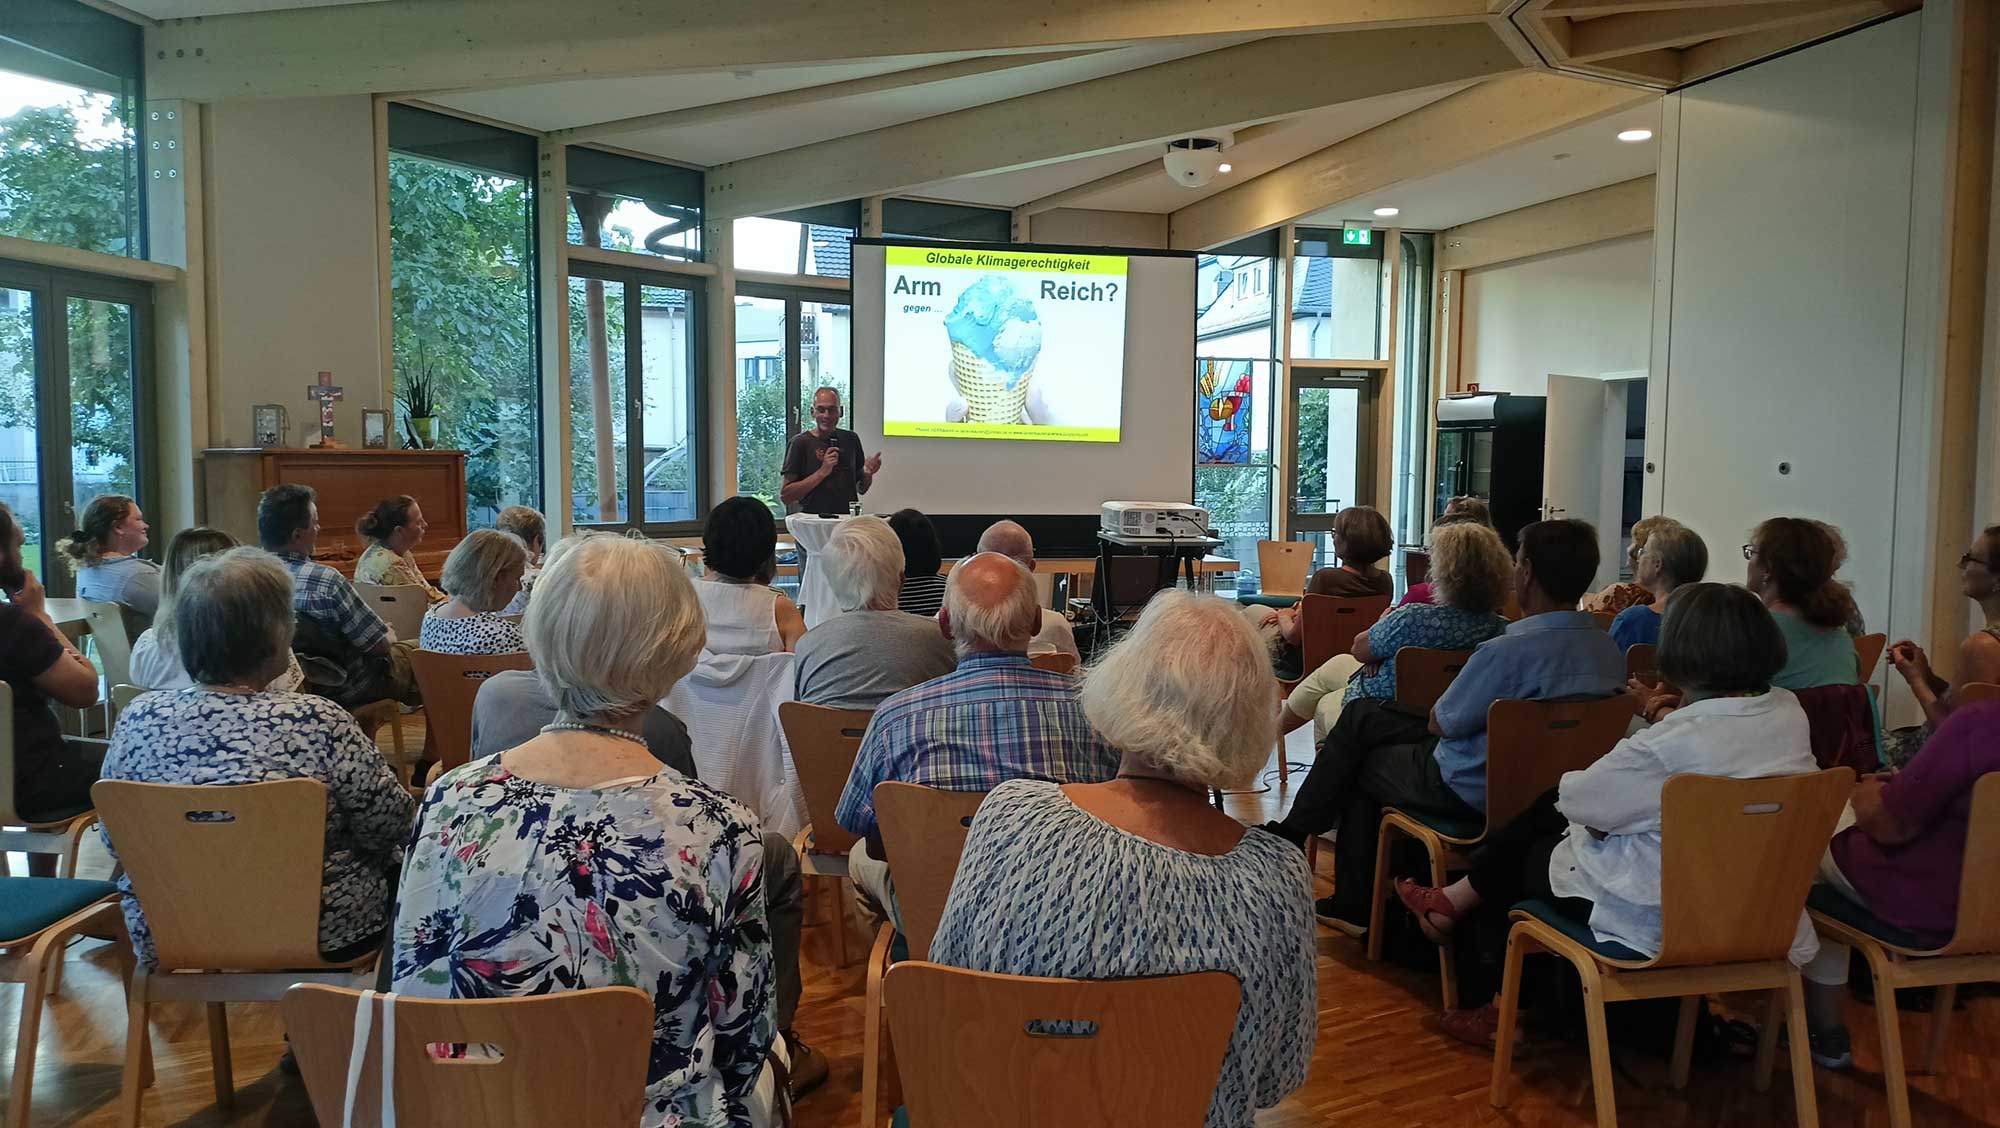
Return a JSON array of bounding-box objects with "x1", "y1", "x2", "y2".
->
[{"x1": 1292, "y1": 228, "x2": 1388, "y2": 360}]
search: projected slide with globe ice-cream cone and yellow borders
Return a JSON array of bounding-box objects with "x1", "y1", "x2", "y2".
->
[{"x1": 882, "y1": 246, "x2": 1132, "y2": 442}]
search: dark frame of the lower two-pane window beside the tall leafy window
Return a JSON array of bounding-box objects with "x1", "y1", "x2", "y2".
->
[{"x1": 568, "y1": 258, "x2": 714, "y2": 538}]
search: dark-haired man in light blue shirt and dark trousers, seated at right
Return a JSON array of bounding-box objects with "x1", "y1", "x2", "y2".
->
[{"x1": 1270, "y1": 520, "x2": 1624, "y2": 930}]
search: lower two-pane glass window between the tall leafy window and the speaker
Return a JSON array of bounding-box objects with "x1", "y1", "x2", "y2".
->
[{"x1": 570, "y1": 262, "x2": 706, "y2": 532}]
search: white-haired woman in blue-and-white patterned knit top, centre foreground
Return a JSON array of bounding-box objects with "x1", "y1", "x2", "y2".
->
[{"x1": 930, "y1": 592, "x2": 1318, "y2": 1128}]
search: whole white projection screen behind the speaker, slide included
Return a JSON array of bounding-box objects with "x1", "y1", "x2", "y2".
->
[{"x1": 846, "y1": 238, "x2": 1192, "y2": 516}]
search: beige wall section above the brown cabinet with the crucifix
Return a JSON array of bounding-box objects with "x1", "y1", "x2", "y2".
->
[{"x1": 206, "y1": 96, "x2": 386, "y2": 446}]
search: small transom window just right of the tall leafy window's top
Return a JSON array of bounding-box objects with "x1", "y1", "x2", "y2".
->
[{"x1": 568, "y1": 146, "x2": 704, "y2": 262}]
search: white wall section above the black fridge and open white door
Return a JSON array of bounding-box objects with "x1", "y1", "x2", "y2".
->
[{"x1": 1460, "y1": 234, "x2": 1652, "y2": 396}]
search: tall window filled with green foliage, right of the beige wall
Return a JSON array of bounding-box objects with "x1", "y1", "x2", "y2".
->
[{"x1": 388, "y1": 106, "x2": 546, "y2": 528}]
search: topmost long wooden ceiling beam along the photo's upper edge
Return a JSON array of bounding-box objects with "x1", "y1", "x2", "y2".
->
[{"x1": 146, "y1": 0, "x2": 1486, "y2": 102}]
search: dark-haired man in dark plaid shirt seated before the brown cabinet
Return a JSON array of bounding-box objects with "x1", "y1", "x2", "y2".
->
[{"x1": 256, "y1": 484, "x2": 422, "y2": 706}]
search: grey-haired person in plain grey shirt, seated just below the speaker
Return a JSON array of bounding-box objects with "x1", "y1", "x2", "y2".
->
[{"x1": 794, "y1": 516, "x2": 958, "y2": 708}]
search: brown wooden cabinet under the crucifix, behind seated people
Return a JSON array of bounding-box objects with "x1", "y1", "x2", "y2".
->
[{"x1": 202, "y1": 448, "x2": 466, "y2": 576}]
